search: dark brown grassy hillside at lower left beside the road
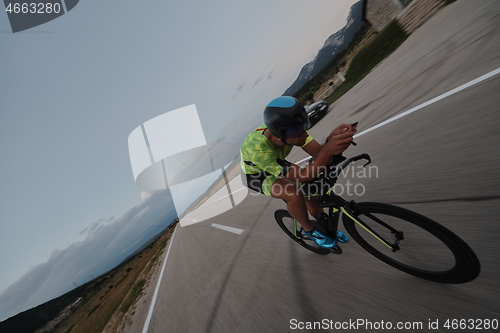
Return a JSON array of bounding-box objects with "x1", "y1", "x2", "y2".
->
[{"x1": 0, "y1": 223, "x2": 177, "y2": 333}]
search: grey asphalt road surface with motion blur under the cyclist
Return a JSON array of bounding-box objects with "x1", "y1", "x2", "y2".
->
[{"x1": 124, "y1": 0, "x2": 500, "y2": 332}]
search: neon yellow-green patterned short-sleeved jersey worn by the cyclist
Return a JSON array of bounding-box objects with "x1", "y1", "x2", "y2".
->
[{"x1": 240, "y1": 125, "x2": 313, "y2": 195}]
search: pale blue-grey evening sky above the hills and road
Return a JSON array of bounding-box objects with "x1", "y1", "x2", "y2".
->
[{"x1": 0, "y1": 0, "x2": 356, "y2": 321}]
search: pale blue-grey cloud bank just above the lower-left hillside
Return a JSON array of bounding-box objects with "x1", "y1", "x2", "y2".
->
[{"x1": 0, "y1": 191, "x2": 177, "y2": 321}]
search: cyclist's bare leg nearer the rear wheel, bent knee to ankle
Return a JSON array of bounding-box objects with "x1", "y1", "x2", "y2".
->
[{"x1": 270, "y1": 178, "x2": 313, "y2": 231}]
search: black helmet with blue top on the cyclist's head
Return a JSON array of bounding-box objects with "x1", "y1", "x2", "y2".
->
[{"x1": 264, "y1": 96, "x2": 309, "y2": 139}]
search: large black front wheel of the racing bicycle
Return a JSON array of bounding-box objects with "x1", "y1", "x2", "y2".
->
[{"x1": 342, "y1": 202, "x2": 481, "y2": 283}]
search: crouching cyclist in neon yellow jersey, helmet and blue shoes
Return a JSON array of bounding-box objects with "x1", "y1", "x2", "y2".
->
[{"x1": 241, "y1": 96, "x2": 356, "y2": 248}]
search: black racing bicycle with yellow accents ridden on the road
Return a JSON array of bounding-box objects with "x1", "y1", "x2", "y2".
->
[{"x1": 275, "y1": 154, "x2": 481, "y2": 283}]
